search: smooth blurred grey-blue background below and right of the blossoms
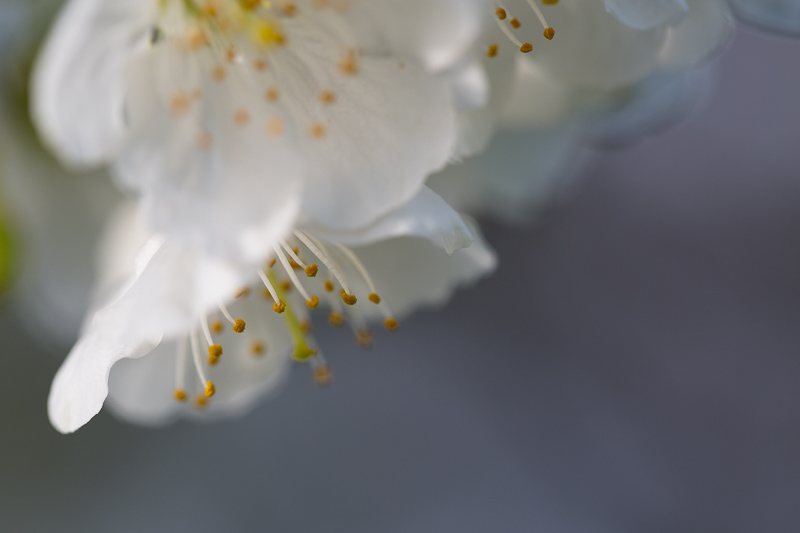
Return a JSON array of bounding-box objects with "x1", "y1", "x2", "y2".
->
[{"x1": 0, "y1": 19, "x2": 800, "y2": 533}]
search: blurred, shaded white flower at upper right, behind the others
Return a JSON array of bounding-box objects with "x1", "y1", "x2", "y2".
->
[{"x1": 431, "y1": 0, "x2": 733, "y2": 219}]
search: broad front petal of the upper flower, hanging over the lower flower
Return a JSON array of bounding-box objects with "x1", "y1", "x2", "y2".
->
[{"x1": 115, "y1": 45, "x2": 303, "y2": 262}]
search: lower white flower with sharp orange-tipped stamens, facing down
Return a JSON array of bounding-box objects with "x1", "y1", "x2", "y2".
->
[{"x1": 49, "y1": 190, "x2": 494, "y2": 432}]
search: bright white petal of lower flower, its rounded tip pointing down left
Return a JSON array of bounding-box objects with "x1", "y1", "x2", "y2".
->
[{"x1": 48, "y1": 237, "x2": 250, "y2": 433}]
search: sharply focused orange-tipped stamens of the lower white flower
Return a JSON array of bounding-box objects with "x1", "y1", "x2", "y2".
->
[{"x1": 174, "y1": 230, "x2": 398, "y2": 407}]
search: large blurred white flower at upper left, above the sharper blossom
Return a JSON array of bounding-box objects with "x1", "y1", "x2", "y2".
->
[{"x1": 33, "y1": 0, "x2": 484, "y2": 259}]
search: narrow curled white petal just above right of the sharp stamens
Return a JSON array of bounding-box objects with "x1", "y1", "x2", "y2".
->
[{"x1": 314, "y1": 187, "x2": 473, "y2": 254}]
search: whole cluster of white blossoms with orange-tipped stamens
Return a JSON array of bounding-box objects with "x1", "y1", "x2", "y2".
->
[{"x1": 0, "y1": 0, "x2": 798, "y2": 433}]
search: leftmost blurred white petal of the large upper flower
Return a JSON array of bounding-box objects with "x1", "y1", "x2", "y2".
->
[{"x1": 32, "y1": 0, "x2": 157, "y2": 166}]
